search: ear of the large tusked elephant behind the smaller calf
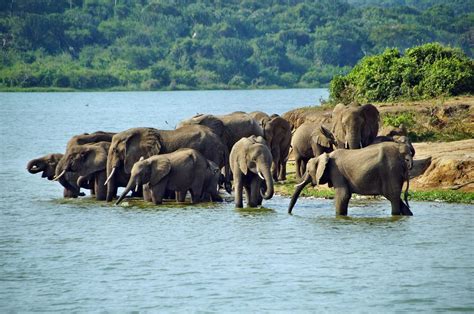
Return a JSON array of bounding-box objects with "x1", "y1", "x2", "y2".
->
[{"x1": 124, "y1": 128, "x2": 161, "y2": 173}]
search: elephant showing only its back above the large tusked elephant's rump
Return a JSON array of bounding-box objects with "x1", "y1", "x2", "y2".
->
[{"x1": 177, "y1": 111, "x2": 263, "y2": 151}]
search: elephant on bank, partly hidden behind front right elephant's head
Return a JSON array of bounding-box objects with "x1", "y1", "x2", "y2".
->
[{"x1": 291, "y1": 121, "x2": 337, "y2": 180}]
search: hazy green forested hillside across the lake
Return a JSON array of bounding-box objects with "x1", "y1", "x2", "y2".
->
[{"x1": 0, "y1": 0, "x2": 474, "y2": 89}]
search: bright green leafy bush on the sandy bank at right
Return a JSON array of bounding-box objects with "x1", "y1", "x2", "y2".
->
[{"x1": 330, "y1": 43, "x2": 474, "y2": 103}]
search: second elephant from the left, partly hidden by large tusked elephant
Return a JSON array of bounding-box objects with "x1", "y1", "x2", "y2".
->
[{"x1": 53, "y1": 142, "x2": 124, "y2": 201}]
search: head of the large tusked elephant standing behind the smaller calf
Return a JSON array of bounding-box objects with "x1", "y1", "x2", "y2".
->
[{"x1": 106, "y1": 128, "x2": 161, "y2": 189}]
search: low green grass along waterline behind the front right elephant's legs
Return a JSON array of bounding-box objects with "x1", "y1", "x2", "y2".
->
[{"x1": 275, "y1": 162, "x2": 474, "y2": 204}]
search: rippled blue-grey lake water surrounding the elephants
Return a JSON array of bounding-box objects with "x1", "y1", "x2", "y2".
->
[{"x1": 0, "y1": 89, "x2": 474, "y2": 313}]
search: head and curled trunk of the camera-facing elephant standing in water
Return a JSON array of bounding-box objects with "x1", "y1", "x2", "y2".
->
[{"x1": 237, "y1": 136, "x2": 274, "y2": 200}]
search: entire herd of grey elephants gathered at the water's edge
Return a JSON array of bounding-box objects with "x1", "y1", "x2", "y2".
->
[{"x1": 27, "y1": 104, "x2": 415, "y2": 215}]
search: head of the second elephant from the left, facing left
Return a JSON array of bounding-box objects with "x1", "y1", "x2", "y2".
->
[{"x1": 59, "y1": 142, "x2": 110, "y2": 183}]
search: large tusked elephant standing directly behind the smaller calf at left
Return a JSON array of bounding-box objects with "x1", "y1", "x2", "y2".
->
[{"x1": 106, "y1": 125, "x2": 230, "y2": 202}]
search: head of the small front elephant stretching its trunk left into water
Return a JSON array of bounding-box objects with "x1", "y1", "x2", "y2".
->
[{"x1": 115, "y1": 156, "x2": 171, "y2": 205}]
